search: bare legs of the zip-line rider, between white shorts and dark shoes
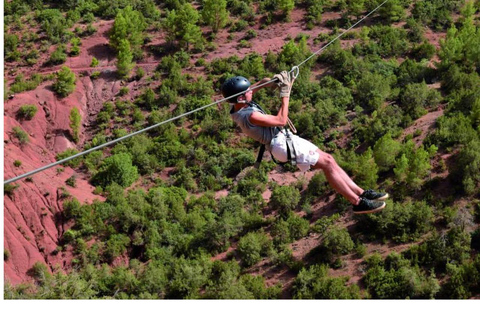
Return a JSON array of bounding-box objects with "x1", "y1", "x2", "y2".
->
[{"x1": 313, "y1": 150, "x2": 363, "y2": 205}]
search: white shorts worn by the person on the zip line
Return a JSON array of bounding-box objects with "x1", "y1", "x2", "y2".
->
[{"x1": 270, "y1": 130, "x2": 320, "y2": 172}]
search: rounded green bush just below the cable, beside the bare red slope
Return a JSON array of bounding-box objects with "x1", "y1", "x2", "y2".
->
[{"x1": 93, "y1": 153, "x2": 138, "y2": 187}]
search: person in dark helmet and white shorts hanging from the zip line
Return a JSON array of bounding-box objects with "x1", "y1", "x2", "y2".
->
[{"x1": 222, "y1": 71, "x2": 388, "y2": 214}]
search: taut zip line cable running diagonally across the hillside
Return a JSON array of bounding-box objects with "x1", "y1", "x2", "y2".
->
[{"x1": 3, "y1": 0, "x2": 389, "y2": 185}]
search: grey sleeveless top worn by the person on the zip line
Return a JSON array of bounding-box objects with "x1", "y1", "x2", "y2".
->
[{"x1": 230, "y1": 102, "x2": 279, "y2": 146}]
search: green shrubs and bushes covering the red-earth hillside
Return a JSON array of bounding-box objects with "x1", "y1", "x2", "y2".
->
[{"x1": 4, "y1": 0, "x2": 480, "y2": 299}]
